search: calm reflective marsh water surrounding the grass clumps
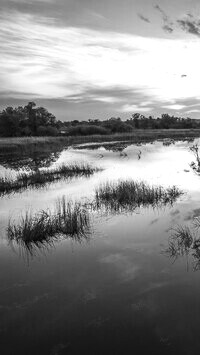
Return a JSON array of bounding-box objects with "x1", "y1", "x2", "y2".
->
[{"x1": 0, "y1": 140, "x2": 200, "y2": 355}]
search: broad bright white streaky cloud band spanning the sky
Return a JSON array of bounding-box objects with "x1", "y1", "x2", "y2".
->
[{"x1": 0, "y1": 12, "x2": 200, "y2": 108}]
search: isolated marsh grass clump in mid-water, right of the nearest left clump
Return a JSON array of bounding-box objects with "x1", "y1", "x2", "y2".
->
[{"x1": 95, "y1": 180, "x2": 182, "y2": 212}]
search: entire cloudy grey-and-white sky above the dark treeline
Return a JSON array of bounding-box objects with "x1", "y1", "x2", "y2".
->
[{"x1": 0, "y1": 0, "x2": 200, "y2": 120}]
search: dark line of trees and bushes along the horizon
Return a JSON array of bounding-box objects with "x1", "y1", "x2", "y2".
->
[{"x1": 0, "y1": 102, "x2": 200, "y2": 137}]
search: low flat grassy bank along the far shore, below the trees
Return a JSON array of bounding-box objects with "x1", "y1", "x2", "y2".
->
[{"x1": 0, "y1": 129, "x2": 200, "y2": 155}]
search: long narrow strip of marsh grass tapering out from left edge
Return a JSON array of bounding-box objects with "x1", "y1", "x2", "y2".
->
[{"x1": 0, "y1": 164, "x2": 101, "y2": 195}]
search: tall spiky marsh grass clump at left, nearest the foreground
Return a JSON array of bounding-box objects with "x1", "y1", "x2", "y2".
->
[{"x1": 7, "y1": 197, "x2": 90, "y2": 255}]
